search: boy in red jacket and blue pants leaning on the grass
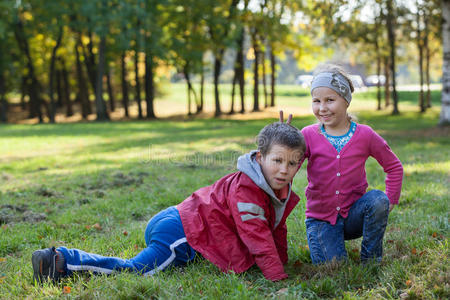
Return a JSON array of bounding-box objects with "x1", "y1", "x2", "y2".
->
[{"x1": 32, "y1": 122, "x2": 305, "y2": 282}]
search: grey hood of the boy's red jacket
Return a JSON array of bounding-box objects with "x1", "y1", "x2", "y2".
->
[{"x1": 237, "y1": 150, "x2": 291, "y2": 206}]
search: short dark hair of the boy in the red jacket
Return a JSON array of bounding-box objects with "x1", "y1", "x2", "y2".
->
[{"x1": 256, "y1": 122, "x2": 306, "y2": 155}]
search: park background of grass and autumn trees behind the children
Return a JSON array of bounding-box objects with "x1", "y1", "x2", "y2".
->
[{"x1": 0, "y1": 0, "x2": 450, "y2": 299}]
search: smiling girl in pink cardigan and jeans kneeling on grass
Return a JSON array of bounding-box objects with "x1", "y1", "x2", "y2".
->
[{"x1": 280, "y1": 65, "x2": 403, "y2": 264}]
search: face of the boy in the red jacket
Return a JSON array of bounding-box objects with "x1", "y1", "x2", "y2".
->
[{"x1": 256, "y1": 144, "x2": 303, "y2": 190}]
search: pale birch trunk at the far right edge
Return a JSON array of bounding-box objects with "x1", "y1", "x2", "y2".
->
[{"x1": 439, "y1": 0, "x2": 450, "y2": 126}]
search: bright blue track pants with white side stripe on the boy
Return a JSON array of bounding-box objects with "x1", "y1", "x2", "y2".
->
[{"x1": 57, "y1": 206, "x2": 196, "y2": 275}]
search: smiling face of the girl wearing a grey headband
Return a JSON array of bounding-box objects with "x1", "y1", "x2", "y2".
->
[{"x1": 312, "y1": 87, "x2": 348, "y2": 129}]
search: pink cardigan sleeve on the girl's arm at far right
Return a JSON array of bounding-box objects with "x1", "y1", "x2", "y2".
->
[{"x1": 370, "y1": 131, "x2": 403, "y2": 204}]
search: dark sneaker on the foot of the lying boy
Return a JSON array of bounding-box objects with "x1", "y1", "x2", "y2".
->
[{"x1": 31, "y1": 247, "x2": 64, "y2": 283}]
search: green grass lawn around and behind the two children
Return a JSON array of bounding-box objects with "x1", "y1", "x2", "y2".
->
[{"x1": 0, "y1": 87, "x2": 450, "y2": 299}]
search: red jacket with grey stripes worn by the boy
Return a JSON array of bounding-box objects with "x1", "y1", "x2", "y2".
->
[{"x1": 177, "y1": 172, "x2": 299, "y2": 281}]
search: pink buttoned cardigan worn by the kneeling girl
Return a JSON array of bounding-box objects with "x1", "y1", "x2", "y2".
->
[{"x1": 302, "y1": 124, "x2": 403, "y2": 225}]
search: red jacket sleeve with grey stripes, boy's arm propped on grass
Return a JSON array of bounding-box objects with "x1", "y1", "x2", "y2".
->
[{"x1": 230, "y1": 186, "x2": 288, "y2": 281}]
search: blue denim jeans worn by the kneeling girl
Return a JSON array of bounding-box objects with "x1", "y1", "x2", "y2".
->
[{"x1": 305, "y1": 190, "x2": 389, "y2": 264}]
